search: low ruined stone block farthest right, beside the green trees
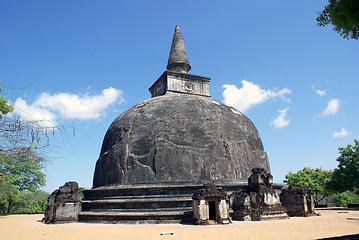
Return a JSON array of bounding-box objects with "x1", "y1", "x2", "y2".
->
[{"x1": 280, "y1": 187, "x2": 315, "y2": 217}]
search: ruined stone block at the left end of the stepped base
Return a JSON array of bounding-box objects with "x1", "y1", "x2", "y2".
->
[{"x1": 42, "y1": 182, "x2": 81, "y2": 223}]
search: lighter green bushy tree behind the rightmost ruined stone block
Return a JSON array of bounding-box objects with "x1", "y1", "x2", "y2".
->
[{"x1": 283, "y1": 167, "x2": 332, "y2": 203}]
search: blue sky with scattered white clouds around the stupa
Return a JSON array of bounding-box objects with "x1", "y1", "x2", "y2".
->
[{"x1": 0, "y1": 0, "x2": 359, "y2": 192}]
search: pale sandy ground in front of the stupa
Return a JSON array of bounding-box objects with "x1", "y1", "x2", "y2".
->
[{"x1": 0, "y1": 209, "x2": 359, "y2": 240}]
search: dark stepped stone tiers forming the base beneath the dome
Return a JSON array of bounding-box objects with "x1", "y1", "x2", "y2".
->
[{"x1": 78, "y1": 183, "x2": 281, "y2": 224}]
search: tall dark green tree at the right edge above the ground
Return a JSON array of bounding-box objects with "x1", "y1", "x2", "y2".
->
[{"x1": 328, "y1": 139, "x2": 359, "y2": 193}]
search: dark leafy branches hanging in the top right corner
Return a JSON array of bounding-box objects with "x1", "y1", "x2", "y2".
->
[{"x1": 316, "y1": 0, "x2": 359, "y2": 40}]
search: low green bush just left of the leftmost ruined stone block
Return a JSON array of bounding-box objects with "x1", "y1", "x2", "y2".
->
[{"x1": 13, "y1": 190, "x2": 49, "y2": 213}]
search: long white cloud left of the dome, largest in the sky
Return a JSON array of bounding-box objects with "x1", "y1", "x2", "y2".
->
[{"x1": 14, "y1": 87, "x2": 123, "y2": 125}]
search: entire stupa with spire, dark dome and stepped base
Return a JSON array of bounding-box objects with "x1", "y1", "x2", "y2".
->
[{"x1": 79, "y1": 26, "x2": 276, "y2": 222}]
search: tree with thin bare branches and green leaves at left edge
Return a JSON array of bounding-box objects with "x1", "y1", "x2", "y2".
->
[{"x1": 0, "y1": 83, "x2": 59, "y2": 213}]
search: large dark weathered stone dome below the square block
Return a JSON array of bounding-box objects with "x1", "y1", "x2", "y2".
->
[{"x1": 93, "y1": 94, "x2": 270, "y2": 187}]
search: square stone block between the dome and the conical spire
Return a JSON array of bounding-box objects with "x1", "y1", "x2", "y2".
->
[{"x1": 149, "y1": 70, "x2": 211, "y2": 97}]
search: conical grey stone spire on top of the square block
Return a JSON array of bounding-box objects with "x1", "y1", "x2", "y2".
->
[{"x1": 167, "y1": 26, "x2": 191, "y2": 73}]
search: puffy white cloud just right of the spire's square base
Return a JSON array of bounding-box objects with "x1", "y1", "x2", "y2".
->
[{"x1": 223, "y1": 80, "x2": 292, "y2": 112}]
